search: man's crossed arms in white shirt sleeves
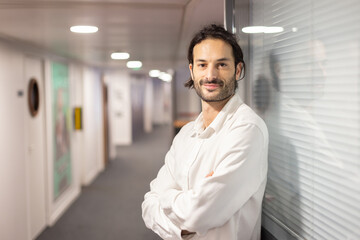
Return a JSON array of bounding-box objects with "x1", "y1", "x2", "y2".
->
[{"x1": 142, "y1": 125, "x2": 264, "y2": 239}]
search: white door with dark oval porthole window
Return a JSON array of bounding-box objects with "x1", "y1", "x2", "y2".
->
[{"x1": 25, "y1": 57, "x2": 46, "y2": 239}]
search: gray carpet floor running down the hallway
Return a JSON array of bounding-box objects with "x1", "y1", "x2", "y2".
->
[{"x1": 37, "y1": 126, "x2": 173, "y2": 240}]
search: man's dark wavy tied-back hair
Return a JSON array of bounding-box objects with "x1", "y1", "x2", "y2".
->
[{"x1": 184, "y1": 24, "x2": 245, "y2": 88}]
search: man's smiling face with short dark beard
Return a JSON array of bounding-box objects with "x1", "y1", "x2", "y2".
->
[{"x1": 189, "y1": 39, "x2": 241, "y2": 102}]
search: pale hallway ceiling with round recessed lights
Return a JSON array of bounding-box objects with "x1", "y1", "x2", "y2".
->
[{"x1": 0, "y1": 0, "x2": 224, "y2": 73}]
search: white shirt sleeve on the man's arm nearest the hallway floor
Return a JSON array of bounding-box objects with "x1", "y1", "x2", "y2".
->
[{"x1": 142, "y1": 143, "x2": 181, "y2": 239}]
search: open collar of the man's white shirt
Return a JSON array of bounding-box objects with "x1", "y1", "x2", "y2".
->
[{"x1": 192, "y1": 93, "x2": 243, "y2": 138}]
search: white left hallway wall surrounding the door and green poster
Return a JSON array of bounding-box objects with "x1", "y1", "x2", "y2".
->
[{"x1": 0, "y1": 40, "x2": 104, "y2": 240}]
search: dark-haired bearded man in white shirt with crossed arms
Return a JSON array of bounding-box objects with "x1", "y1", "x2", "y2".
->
[{"x1": 142, "y1": 25, "x2": 268, "y2": 240}]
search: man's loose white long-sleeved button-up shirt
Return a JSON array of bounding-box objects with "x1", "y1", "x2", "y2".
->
[{"x1": 142, "y1": 95, "x2": 268, "y2": 240}]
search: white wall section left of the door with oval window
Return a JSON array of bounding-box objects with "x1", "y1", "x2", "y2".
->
[{"x1": 0, "y1": 42, "x2": 29, "y2": 240}]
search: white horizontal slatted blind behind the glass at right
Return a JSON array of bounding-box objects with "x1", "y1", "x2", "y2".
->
[{"x1": 248, "y1": 0, "x2": 360, "y2": 240}]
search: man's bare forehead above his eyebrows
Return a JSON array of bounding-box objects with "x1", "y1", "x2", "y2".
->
[{"x1": 193, "y1": 38, "x2": 234, "y2": 60}]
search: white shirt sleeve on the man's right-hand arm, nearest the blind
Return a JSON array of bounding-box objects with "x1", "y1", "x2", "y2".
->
[{"x1": 160, "y1": 124, "x2": 267, "y2": 236}]
